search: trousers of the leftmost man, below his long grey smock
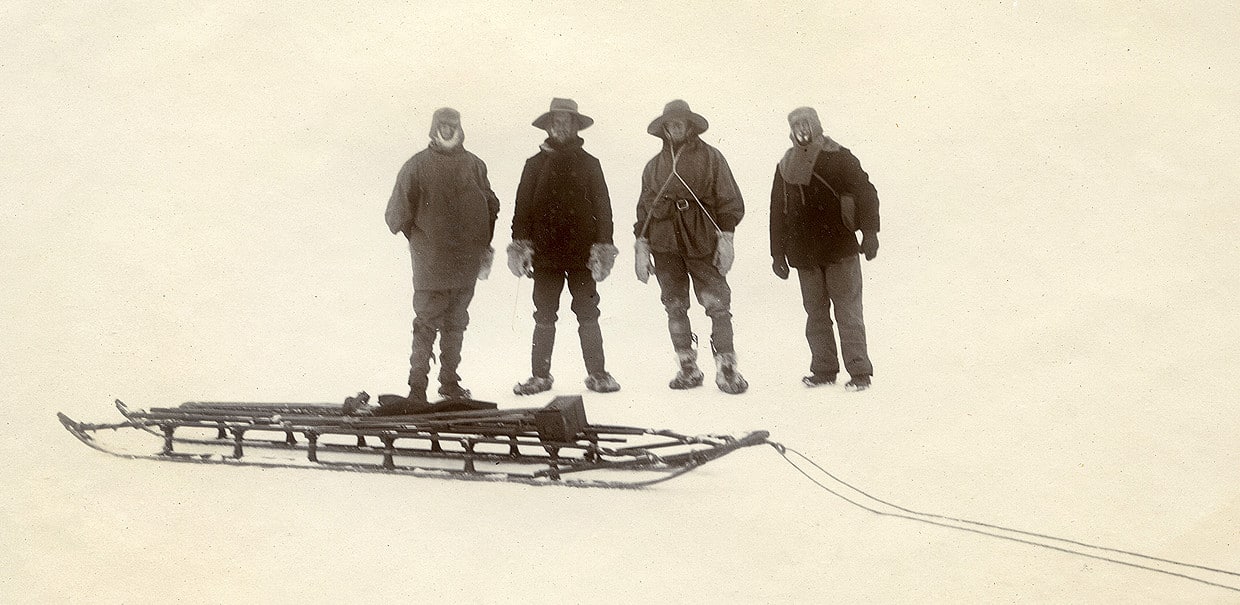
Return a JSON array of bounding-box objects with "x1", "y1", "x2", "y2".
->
[{"x1": 409, "y1": 283, "x2": 475, "y2": 392}]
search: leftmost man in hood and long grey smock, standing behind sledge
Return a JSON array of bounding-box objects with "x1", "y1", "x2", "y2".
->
[{"x1": 377, "y1": 108, "x2": 500, "y2": 413}]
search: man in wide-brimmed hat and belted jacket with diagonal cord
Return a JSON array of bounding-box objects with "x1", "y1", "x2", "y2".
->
[{"x1": 634, "y1": 99, "x2": 749, "y2": 393}]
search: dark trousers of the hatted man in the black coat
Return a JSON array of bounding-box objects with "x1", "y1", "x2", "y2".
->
[{"x1": 529, "y1": 267, "x2": 606, "y2": 377}]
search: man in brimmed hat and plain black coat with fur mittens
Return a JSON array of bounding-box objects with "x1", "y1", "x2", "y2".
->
[{"x1": 507, "y1": 98, "x2": 620, "y2": 395}]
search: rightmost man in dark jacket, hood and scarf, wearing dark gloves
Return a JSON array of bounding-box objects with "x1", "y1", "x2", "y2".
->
[{"x1": 770, "y1": 107, "x2": 879, "y2": 391}]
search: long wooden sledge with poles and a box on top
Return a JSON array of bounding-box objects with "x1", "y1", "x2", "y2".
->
[{"x1": 57, "y1": 392, "x2": 774, "y2": 487}]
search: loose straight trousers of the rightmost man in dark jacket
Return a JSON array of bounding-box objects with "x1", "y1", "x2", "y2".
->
[{"x1": 797, "y1": 254, "x2": 874, "y2": 376}]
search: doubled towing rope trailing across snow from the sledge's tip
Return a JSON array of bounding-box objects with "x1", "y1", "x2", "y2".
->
[{"x1": 768, "y1": 441, "x2": 1240, "y2": 593}]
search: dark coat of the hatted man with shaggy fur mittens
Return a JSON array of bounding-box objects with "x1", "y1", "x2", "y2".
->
[{"x1": 512, "y1": 138, "x2": 613, "y2": 270}]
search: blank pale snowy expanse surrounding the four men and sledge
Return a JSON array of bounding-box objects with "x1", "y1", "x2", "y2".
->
[{"x1": 0, "y1": 1, "x2": 1240, "y2": 604}]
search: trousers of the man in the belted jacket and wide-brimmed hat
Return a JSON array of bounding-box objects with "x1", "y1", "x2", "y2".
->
[{"x1": 652, "y1": 252, "x2": 735, "y2": 353}]
